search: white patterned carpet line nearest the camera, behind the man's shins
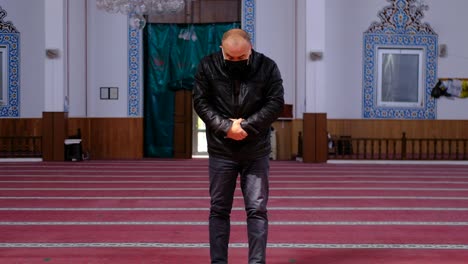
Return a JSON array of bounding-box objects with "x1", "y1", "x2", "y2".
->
[{"x1": 0, "y1": 242, "x2": 468, "y2": 250}]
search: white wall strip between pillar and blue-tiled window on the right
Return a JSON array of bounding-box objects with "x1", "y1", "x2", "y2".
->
[{"x1": 323, "y1": 0, "x2": 382, "y2": 118}]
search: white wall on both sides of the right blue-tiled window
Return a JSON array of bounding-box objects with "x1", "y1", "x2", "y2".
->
[{"x1": 323, "y1": 0, "x2": 468, "y2": 119}]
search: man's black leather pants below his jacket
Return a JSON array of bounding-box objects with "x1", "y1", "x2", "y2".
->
[{"x1": 209, "y1": 156, "x2": 269, "y2": 264}]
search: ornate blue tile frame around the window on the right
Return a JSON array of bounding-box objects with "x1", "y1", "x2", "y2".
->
[{"x1": 362, "y1": 0, "x2": 438, "y2": 119}]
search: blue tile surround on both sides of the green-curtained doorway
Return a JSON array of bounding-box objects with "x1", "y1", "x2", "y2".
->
[{"x1": 128, "y1": 0, "x2": 255, "y2": 117}]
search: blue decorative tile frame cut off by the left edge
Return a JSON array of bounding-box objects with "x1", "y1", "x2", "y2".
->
[{"x1": 0, "y1": 7, "x2": 20, "y2": 117}]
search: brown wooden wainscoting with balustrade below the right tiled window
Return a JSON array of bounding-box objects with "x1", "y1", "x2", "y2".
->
[{"x1": 328, "y1": 120, "x2": 468, "y2": 160}]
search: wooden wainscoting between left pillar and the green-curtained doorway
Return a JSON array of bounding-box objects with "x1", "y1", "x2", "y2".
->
[{"x1": 68, "y1": 118, "x2": 143, "y2": 160}]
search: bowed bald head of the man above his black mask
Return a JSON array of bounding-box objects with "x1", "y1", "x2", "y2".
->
[{"x1": 221, "y1": 28, "x2": 252, "y2": 61}]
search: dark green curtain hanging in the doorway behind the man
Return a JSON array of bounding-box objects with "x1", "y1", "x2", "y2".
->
[{"x1": 144, "y1": 23, "x2": 240, "y2": 158}]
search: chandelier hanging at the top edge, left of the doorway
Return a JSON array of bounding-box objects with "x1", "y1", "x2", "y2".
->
[{"x1": 96, "y1": 0, "x2": 185, "y2": 29}]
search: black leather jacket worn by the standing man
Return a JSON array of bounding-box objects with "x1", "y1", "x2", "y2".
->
[{"x1": 193, "y1": 50, "x2": 284, "y2": 159}]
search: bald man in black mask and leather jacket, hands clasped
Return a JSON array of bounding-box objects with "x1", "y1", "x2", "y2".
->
[{"x1": 193, "y1": 29, "x2": 284, "y2": 264}]
